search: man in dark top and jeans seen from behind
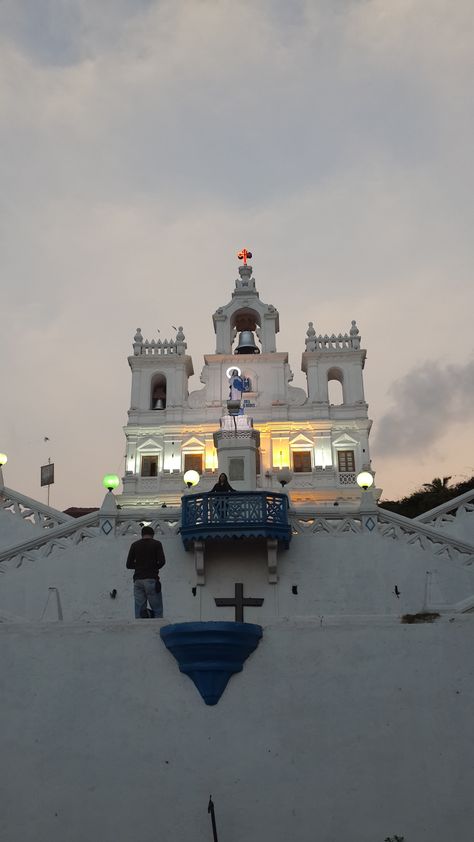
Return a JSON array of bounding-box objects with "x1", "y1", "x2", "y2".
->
[{"x1": 127, "y1": 526, "x2": 165, "y2": 619}]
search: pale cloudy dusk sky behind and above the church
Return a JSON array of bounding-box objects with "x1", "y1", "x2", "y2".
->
[{"x1": 0, "y1": 0, "x2": 474, "y2": 508}]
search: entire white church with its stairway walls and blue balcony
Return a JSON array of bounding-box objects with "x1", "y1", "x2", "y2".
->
[{"x1": 0, "y1": 250, "x2": 474, "y2": 842}]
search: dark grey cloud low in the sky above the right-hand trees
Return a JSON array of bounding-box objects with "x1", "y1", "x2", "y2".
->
[{"x1": 374, "y1": 360, "x2": 474, "y2": 459}]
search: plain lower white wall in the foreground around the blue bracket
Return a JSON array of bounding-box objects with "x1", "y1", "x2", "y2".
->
[{"x1": 0, "y1": 616, "x2": 474, "y2": 842}]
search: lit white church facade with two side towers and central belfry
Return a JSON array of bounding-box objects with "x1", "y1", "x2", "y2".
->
[{"x1": 122, "y1": 264, "x2": 371, "y2": 506}]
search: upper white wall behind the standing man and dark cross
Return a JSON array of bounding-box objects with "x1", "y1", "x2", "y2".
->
[{"x1": 0, "y1": 532, "x2": 474, "y2": 623}]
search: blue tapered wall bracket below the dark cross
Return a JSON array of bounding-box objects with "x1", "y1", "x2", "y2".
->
[{"x1": 160, "y1": 622, "x2": 263, "y2": 705}]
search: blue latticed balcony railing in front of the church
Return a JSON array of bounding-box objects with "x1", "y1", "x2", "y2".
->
[{"x1": 181, "y1": 491, "x2": 291, "y2": 547}]
